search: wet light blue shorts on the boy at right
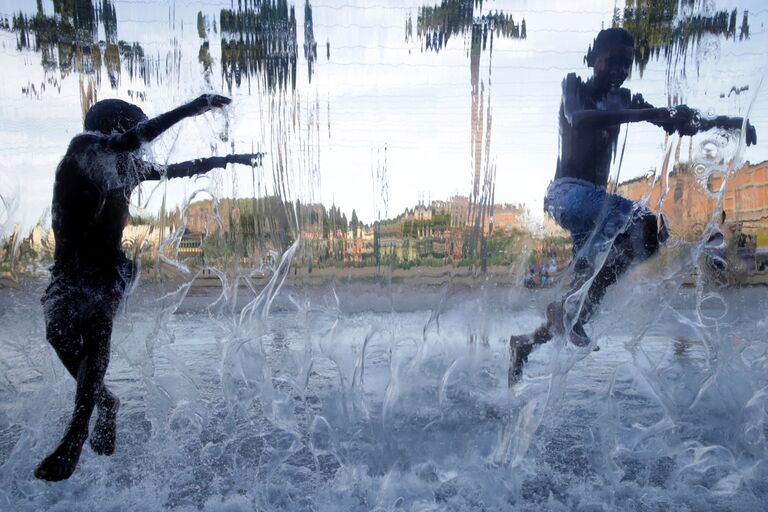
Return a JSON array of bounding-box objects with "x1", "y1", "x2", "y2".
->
[{"x1": 544, "y1": 178, "x2": 650, "y2": 257}]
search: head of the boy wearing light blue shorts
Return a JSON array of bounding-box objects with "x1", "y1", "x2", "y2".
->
[{"x1": 584, "y1": 28, "x2": 635, "y2": 89}]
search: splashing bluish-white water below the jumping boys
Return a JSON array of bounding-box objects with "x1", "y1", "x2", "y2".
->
[{"x1": 0, "y1": 278, "x2": 768, "y2": 510}]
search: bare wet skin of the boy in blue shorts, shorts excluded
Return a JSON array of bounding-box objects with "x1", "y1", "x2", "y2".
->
[{"x1": 508, "y1": 41, "x2": 757, "y2": 386}]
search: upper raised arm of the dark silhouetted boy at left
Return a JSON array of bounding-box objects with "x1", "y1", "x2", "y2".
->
[{"x1": 108, "y1": 94, "x2": 232, "y2": 151}]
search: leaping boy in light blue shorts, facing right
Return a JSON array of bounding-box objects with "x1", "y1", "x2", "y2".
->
[{"x1": 509, "y1": 28, "x2": 757, "y2": 386}]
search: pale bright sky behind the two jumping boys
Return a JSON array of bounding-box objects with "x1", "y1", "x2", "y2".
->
[{"x1": 0, "y1": 0, "x2": 768, "y2": 234}]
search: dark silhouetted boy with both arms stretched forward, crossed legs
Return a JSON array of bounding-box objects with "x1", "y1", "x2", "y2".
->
[{"x1": 35, "y1": 94, "x2": 261, "y2": 481}]
